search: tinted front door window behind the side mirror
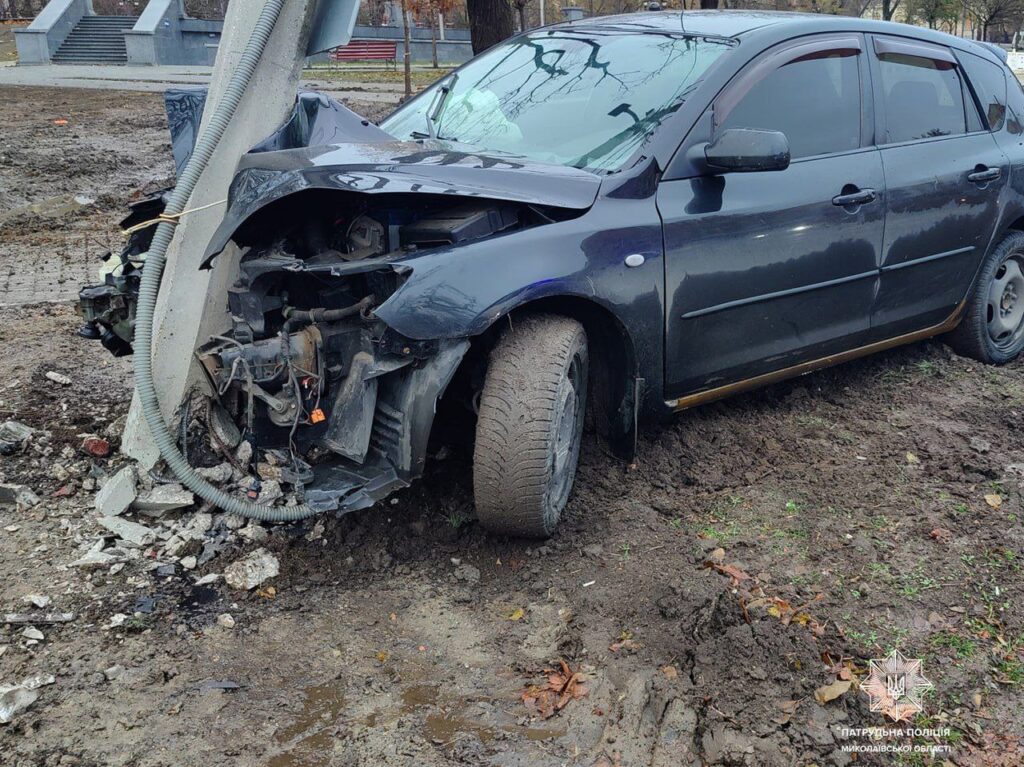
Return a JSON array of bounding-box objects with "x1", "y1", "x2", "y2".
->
[{"x1": 719, "y1": 50, "x2": 860, "y2": 160}]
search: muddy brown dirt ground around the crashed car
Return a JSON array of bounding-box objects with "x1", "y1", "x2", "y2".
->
[{"x1": 0, "y1": 83, "x2": 1024, "y2": 767}]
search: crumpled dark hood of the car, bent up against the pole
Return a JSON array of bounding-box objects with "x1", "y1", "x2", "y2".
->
[{"x1": 203, "y1": 93, "x2": 601, "y2": 268}]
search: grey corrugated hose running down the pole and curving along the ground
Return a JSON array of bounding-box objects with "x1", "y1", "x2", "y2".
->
[{"x1": 134, "y1": 0, "x2": 318, "y2": 522}]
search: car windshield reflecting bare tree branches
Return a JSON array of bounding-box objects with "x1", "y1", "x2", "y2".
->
[{"x1": 381, "y1": 30, "x2": 732, "y2": 171}]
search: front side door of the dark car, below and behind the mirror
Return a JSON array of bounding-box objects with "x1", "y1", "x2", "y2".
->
[{"x1": 657, "y1": 35, "x2": 885, "y2": 407}]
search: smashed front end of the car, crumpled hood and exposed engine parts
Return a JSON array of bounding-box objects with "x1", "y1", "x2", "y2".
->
[{"x1": 81, "y1": 94, "x2": 599, "y2": 512}]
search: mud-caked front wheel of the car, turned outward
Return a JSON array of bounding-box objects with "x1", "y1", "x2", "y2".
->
[{"x1": 473, "y1": 314, "x2": 589, "y2": 538}]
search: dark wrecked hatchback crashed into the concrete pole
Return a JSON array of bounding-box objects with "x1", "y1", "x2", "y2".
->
[{"x1": 81, "y1": 11, "x2": 1024, "y2": 537}]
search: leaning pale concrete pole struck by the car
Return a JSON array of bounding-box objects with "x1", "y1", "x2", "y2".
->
[{"x1": 122, "y1": 0, "x2": 316, "y2": 469}]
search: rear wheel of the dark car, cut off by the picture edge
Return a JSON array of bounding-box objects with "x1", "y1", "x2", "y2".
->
[{"x1": 945, "y1": 231, "x2": 1024, "y2": 365}]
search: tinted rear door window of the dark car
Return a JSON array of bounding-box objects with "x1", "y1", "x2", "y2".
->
[{"x1": 879, "y1": 53, "x2": 967, "y2": 143}]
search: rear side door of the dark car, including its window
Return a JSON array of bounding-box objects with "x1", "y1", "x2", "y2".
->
[{"x1": 869, "y1": 36, "x2": 1010, "y2": 338}]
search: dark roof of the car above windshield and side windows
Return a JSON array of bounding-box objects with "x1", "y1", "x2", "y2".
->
[{"x1": 545, "y1": 10, "x2": 998, "y2": 58}]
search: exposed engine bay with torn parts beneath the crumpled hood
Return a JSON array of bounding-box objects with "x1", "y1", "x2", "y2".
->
[{"x1": 187, "y1": 196, "x2": 543, "y2": 511}]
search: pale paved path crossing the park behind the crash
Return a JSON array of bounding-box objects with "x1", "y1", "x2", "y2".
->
[{"x1": 0, "y1": 65, "x2": 402, "y2": 103}]
